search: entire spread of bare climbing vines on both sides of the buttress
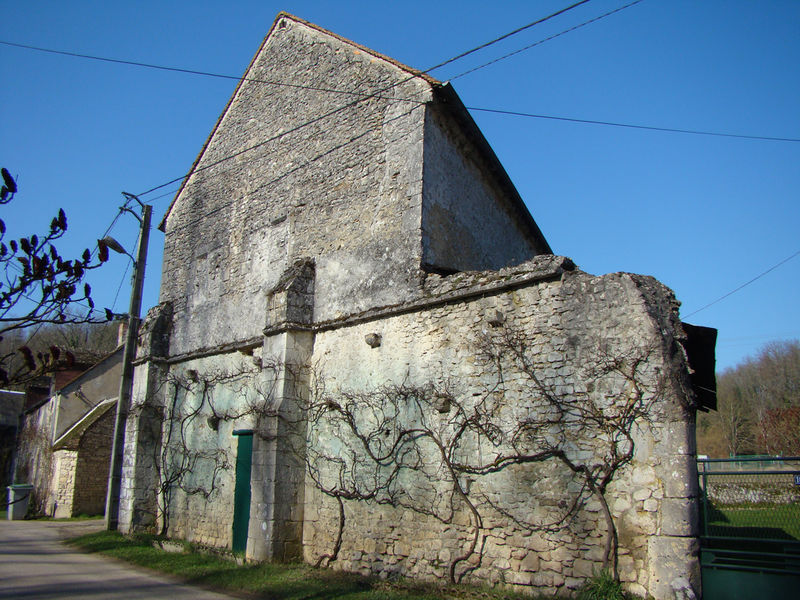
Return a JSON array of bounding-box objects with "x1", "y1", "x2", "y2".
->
[{"x1": 141, "y1": 325, "x2": 665, "y2": 582}]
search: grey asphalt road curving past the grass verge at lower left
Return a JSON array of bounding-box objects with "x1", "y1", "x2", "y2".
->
[{"x1": 0, "y1": 521, "x2": 238, "y2": 600}]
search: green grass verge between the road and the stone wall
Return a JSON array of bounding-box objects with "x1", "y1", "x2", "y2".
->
[{"x1": 69, "y1": 531, "x2": 544, "y2": 600}]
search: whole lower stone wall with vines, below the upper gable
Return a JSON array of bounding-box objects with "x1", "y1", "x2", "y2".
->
[{"x1": 123, "y1": 257, "x2": 700, "y2": 600}]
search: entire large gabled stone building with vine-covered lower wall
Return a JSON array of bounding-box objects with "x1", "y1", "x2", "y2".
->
[{"x1": 119, "y1": 13, "x2": 713, "y2": 599}]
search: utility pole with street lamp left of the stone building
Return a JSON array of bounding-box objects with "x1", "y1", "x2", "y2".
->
[{"x1": 106, "y1": 192, "x2": 153, "y2": 530}]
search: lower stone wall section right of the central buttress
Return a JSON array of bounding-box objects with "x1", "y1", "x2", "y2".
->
[{"x1": 304, "y1": 261, "x2": 699, "y2": 598}]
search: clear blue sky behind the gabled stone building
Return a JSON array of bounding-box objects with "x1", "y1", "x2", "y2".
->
[{"x1": 0, "y1": 0, "x2": 800, "y2": 368}]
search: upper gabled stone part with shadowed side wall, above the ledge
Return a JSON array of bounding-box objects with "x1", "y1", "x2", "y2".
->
[{"x1": 161, "y1": 17, "x2": 549, "y2": 356}]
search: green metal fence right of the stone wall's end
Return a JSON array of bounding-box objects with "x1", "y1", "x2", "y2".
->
[{"x1": 697, "y1": 457, "x2": 800, "y2": 599}]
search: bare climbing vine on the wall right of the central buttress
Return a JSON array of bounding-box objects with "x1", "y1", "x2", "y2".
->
[{"x1": 305, "y1": 326, "x2": 664, "y2": 582}]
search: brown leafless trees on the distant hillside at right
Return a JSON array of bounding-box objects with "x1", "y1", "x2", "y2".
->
[{"x1": 697, "y1": 340, "x2": 800, "y2": 456}]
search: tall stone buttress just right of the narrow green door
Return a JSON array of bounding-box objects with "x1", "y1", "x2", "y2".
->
[{"x1": 247, "y1": 260, "x2": 314, "y2": 561}]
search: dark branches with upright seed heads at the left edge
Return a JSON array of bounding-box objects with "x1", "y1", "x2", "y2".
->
[{"x1": 0, "y1": 169, "x2": 113, "y2": 386}]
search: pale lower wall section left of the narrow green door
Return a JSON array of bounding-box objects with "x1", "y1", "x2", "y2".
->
[{"x1": 148, "y1": 353, "x2": 269, "y2": 548}]
